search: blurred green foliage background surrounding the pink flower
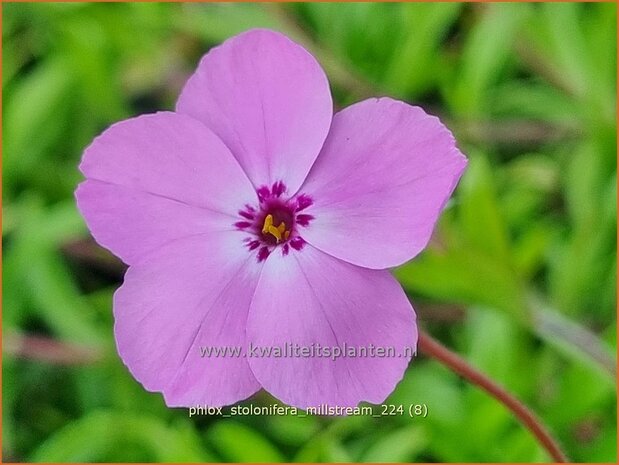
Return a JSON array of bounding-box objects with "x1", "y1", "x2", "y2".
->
[{"x1": 2, "y1": 3, "x2": 617, "y2": 462}]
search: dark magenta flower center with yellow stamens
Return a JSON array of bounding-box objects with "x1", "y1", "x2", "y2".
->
[{"x1": 234, "y1": 181, "x2": 314, "y2": 261}]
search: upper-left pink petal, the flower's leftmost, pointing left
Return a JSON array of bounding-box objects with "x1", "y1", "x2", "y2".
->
[{"x1": 76, "y1": 113, "x2": 256, "y2": 264}]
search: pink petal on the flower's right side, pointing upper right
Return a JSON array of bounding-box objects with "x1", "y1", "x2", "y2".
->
[{"x1": 301, "y1": 98, "x2": 467, "y2": 268}]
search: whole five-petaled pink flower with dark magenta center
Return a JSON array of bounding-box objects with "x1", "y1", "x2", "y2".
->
[{"x1": 76, "y1": 30, "x2": 466, "y2": 407}]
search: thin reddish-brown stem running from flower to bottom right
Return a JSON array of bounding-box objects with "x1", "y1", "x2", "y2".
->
[{"x1": 419, "y1": 331, "x2": 568, "y2": 463}]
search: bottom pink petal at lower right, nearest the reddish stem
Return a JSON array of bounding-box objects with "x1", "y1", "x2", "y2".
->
[{"x1": 247, "y1": 245, "x2": 417, "y2": 408}]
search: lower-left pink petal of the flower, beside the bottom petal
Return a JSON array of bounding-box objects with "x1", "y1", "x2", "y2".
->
[{"x1": 114, "y1": 232, "x2": 260, "y2": 407}]
